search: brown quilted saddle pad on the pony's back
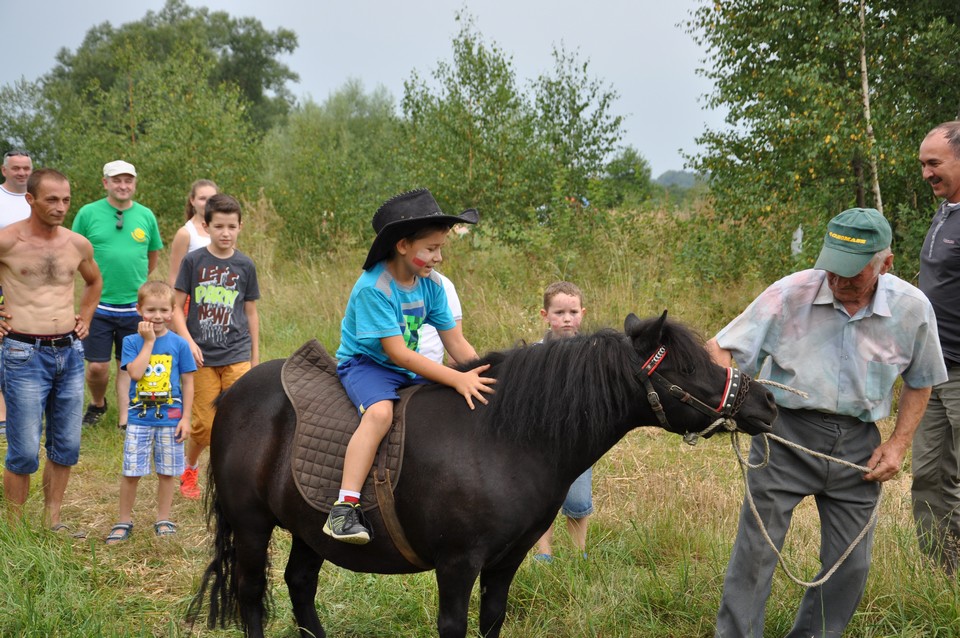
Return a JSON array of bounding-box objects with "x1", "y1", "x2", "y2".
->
[{"x1": 280, "y1": 339, "x2": 412, "y2": 513}]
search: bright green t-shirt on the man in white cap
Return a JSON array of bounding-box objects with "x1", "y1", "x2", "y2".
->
[{"x1": 72, "y1": 197, "x2": 163, "y2": 305}]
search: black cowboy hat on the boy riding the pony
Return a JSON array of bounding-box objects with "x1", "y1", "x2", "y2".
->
[{"x1": 363, "y1": 188, "x2": 480, "y2": 270}]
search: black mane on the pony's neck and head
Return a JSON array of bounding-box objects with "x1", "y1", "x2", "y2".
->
[{"x1": 474, "y1": 319, "x2": 709, "y2": 453}]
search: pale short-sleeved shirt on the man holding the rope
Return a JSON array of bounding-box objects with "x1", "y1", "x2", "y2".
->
[{"x1": 716, "y1": 270, "x2": 947, "y2": 422}]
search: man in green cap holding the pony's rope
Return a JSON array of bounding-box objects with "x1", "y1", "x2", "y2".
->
[{"x1": 707, "y1": 208, "x2": 946, "y2": 638}]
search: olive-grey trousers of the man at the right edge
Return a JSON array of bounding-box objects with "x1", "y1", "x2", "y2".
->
[{"x1": 911, "y1": 366, "x2": 960, "y2": 574}]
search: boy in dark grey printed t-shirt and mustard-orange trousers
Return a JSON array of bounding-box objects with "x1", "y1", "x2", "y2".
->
[{"x1": 173, "y1": 194, "x2": 260, "y2": 499}]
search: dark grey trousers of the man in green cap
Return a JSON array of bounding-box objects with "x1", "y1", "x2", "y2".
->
[{"x1": 716, "y1": 408, "x2": 880, "y2": 638}]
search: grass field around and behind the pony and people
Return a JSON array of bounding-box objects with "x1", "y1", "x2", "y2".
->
[{"x1": 0, "y1": 209, "x2": 960, "y2": 638}]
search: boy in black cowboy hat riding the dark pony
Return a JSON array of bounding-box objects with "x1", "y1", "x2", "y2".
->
[{"x1": 323, "y1": 189, "x2": 496, "y2": 545}]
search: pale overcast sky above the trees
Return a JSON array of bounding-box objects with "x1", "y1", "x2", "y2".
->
[{"x1": 0, "y1": 0, "x2": 723, "y2": 177}]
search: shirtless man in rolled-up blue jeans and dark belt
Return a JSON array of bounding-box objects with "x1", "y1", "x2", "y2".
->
[{"x1": 0, "y1": 169, "x2": 103, "y2": 530}]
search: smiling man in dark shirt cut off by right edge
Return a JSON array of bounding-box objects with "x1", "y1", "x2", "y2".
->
[{"x1": 912, "y1": 122, "x2": 960, "y2": 574}]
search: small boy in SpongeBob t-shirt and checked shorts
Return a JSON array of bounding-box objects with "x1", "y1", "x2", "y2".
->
[{"x1": 106, "y1": 281, "x2": 197, "y2": 545}]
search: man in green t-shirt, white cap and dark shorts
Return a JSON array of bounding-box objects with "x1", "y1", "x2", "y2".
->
[{"x1": 73, "y1": 160, "x2": 163, "y2": 426}]
